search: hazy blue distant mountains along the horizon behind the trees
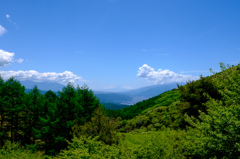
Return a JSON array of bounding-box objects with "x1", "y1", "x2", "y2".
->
[{"x1": 20, "y1": 80, "x2": 185, "y2": 107}]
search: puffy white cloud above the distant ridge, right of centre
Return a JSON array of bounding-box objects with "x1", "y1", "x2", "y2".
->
[{"x1": 137, "y1": 64, "x2": 198, "y2": 84}]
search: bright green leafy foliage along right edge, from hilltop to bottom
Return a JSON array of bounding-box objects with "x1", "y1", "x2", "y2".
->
[{"x1": 187, "y1": 64, "x2": 240, "y2": 158}]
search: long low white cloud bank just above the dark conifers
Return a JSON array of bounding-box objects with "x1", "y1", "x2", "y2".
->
[{"x1": 0, "y1": 70, "x2": 84, "y2": 84}]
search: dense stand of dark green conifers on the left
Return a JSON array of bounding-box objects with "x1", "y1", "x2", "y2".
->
[{"x1": 0, "y1": 78, "x2": 100, "y2": 154}]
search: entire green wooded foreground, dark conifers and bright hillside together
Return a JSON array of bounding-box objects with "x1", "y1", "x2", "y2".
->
[{"x1": 0, "y1": 63, "x2": 240, "y2": 158}]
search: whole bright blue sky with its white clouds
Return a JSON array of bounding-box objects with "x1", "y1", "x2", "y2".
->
[{"x1": 0, "y1": 0, "x2": 240, "y2": 89}]
